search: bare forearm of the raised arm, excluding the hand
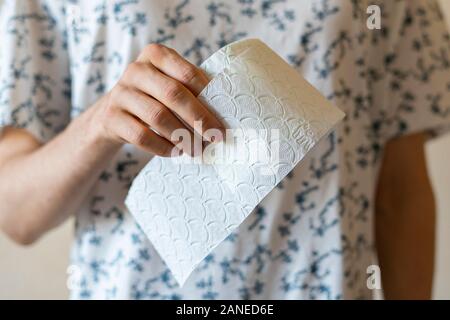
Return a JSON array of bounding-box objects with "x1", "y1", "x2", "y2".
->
[{"x1": 0, "y1": 102, "x2": 120, "y2": 243}]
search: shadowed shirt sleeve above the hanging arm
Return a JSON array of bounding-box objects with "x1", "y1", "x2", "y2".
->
[{"x1": 373, "y1": 0, "x2": 450, "y2": 141}]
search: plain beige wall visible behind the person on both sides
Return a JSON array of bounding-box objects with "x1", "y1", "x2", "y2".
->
[{"x1": 0, "y1": 0, "x2": 450, "y2": 299}]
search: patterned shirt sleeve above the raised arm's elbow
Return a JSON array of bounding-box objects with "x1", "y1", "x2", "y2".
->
[{"x1": 0, "y1": 0, "x2": 71, "y2": 143}]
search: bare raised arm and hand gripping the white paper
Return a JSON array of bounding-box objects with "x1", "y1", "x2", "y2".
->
[{"x1": 0, "y1": 44, "x2": 224, "y2": 244}]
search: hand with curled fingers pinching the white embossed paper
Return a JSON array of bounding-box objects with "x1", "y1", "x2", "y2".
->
[{"x1": 92, "y1": 44, "x2": 224, "y2": 156}]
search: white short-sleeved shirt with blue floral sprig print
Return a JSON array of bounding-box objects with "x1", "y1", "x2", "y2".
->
[{"x1": 0, "y1": 0, "x2": 450, "y2": 299}]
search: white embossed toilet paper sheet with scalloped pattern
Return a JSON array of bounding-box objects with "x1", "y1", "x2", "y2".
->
[{"x1": 125, "y1": 39, "x2": 344, "y2": 286}]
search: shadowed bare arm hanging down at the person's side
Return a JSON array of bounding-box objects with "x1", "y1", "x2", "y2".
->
[{"x1": 376, "y1": 134, "x2": 435, "y2": 299}]
